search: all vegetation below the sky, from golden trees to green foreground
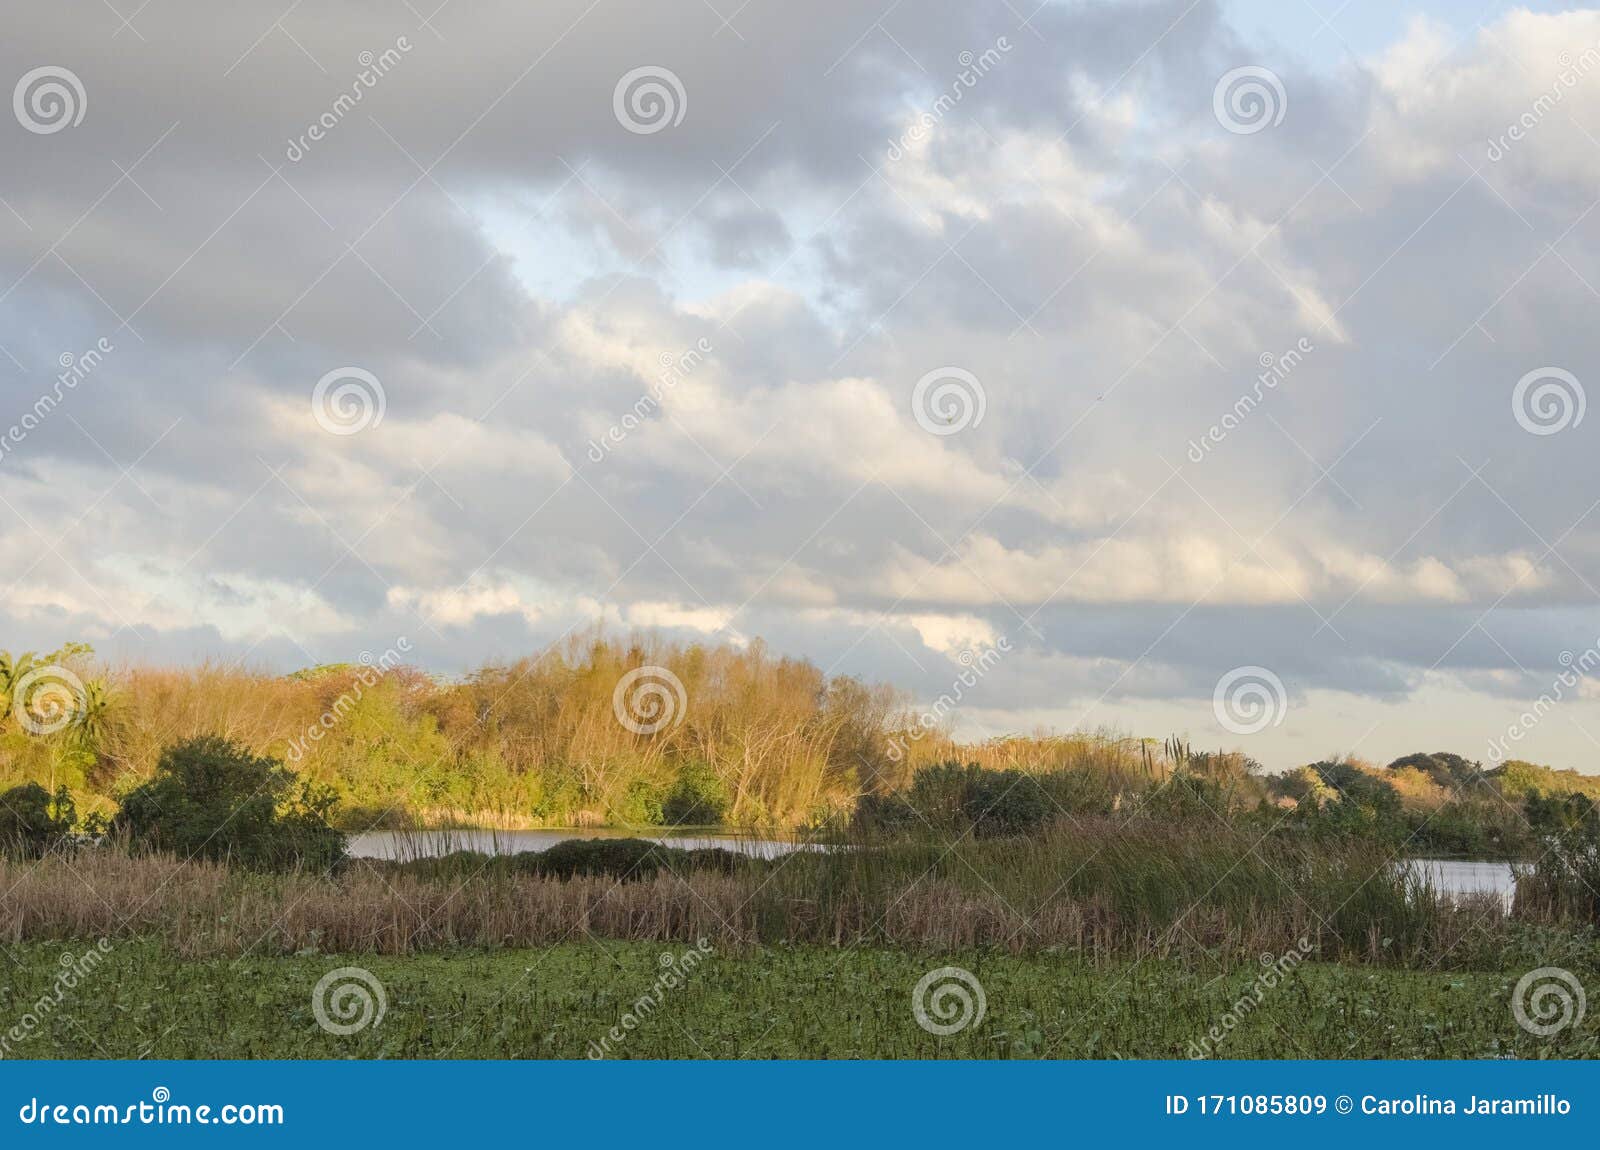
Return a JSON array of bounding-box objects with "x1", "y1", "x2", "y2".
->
[{"x1": 0, "y1": 643, "x2": 1600, "y2": 1057}]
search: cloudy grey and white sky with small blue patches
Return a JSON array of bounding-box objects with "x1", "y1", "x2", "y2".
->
[{"x1": 0, "y1": 0, "x2": 1600, "y2": 771}]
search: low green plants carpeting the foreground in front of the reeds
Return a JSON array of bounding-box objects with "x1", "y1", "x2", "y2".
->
[{"x1": 0, "y1": 940, "x2": 1600, "y2": 1059}]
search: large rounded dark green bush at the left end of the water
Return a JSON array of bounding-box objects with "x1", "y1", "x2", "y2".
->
[{"x1": 112, "y1": 736, "x2": 344, "y2": 870}]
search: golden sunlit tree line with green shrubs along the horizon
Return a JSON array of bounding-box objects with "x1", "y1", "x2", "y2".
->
[{"x1": 0, "y1": 637, "x2": 1600, "y2": 865}]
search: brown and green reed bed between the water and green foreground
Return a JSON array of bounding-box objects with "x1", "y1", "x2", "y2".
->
[{"x1": 0, "y1": 822, "x2": 1561, "y2": 968}]
